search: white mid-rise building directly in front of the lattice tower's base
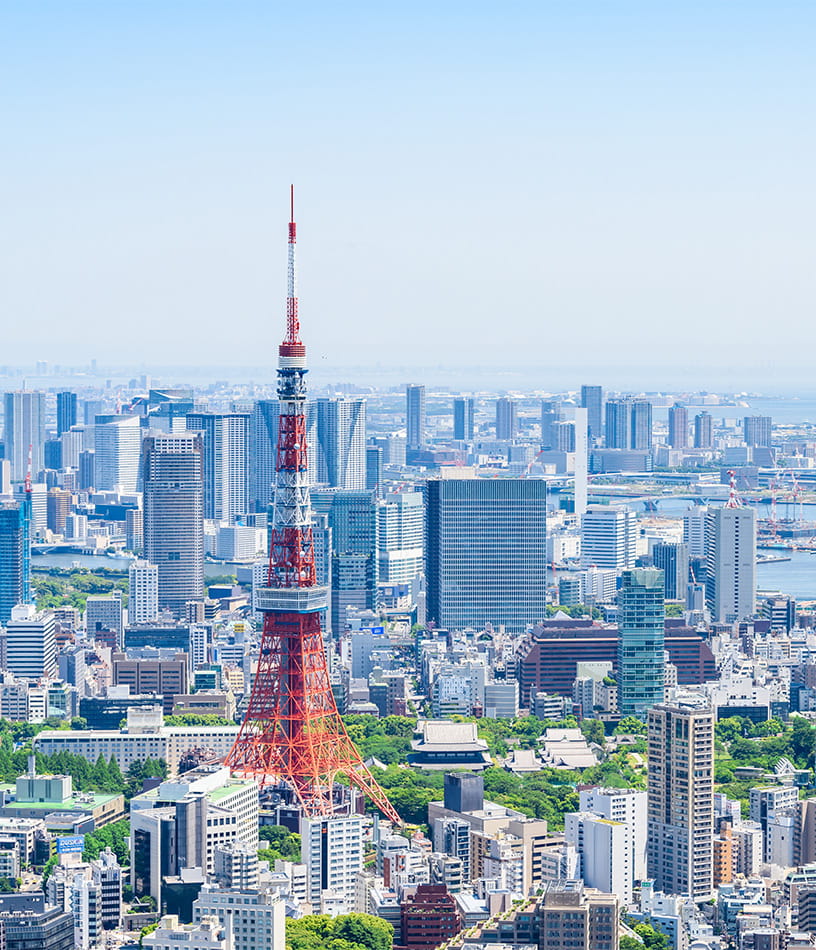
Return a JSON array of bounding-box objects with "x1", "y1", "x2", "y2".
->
[{"x1": 300, "y1": 816, "x2": 363, "y2": 914}]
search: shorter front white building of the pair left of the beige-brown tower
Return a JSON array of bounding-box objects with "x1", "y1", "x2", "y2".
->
[{"x1": 564, "y1": 812, "x2": 633, "y2": 904}]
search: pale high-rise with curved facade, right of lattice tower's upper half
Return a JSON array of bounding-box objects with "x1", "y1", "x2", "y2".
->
[{"x1": 316, "y1": 397, "x2": 366, "y2": 491}]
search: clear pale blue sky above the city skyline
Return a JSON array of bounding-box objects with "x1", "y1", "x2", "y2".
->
[{"x1": 0, "y1": 0, "x2": 816, "y2": 388}]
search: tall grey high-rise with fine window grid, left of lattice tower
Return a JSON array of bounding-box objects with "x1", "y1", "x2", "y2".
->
[{"x1": 142, "y1": 433, "x2": 204, "y2": 617}]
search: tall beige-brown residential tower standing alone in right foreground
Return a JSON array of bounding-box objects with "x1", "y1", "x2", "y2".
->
[{"x1": 646, "y1": 703, "x2": 714, "y2": 901}]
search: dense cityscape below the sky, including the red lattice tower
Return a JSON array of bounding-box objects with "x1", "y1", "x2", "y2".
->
[{"x1": 0, "y1": 193, "x2": 816, "y2": 950}]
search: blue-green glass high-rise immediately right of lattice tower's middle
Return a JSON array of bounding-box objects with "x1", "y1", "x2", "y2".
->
[{"x1": 311, "y1": 488, "x2": 378, "y2": 634}]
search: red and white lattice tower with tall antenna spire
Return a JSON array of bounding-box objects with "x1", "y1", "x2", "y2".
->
[{"x1": 226, "y1": 188, "x2": 400, "y2": 822}]
